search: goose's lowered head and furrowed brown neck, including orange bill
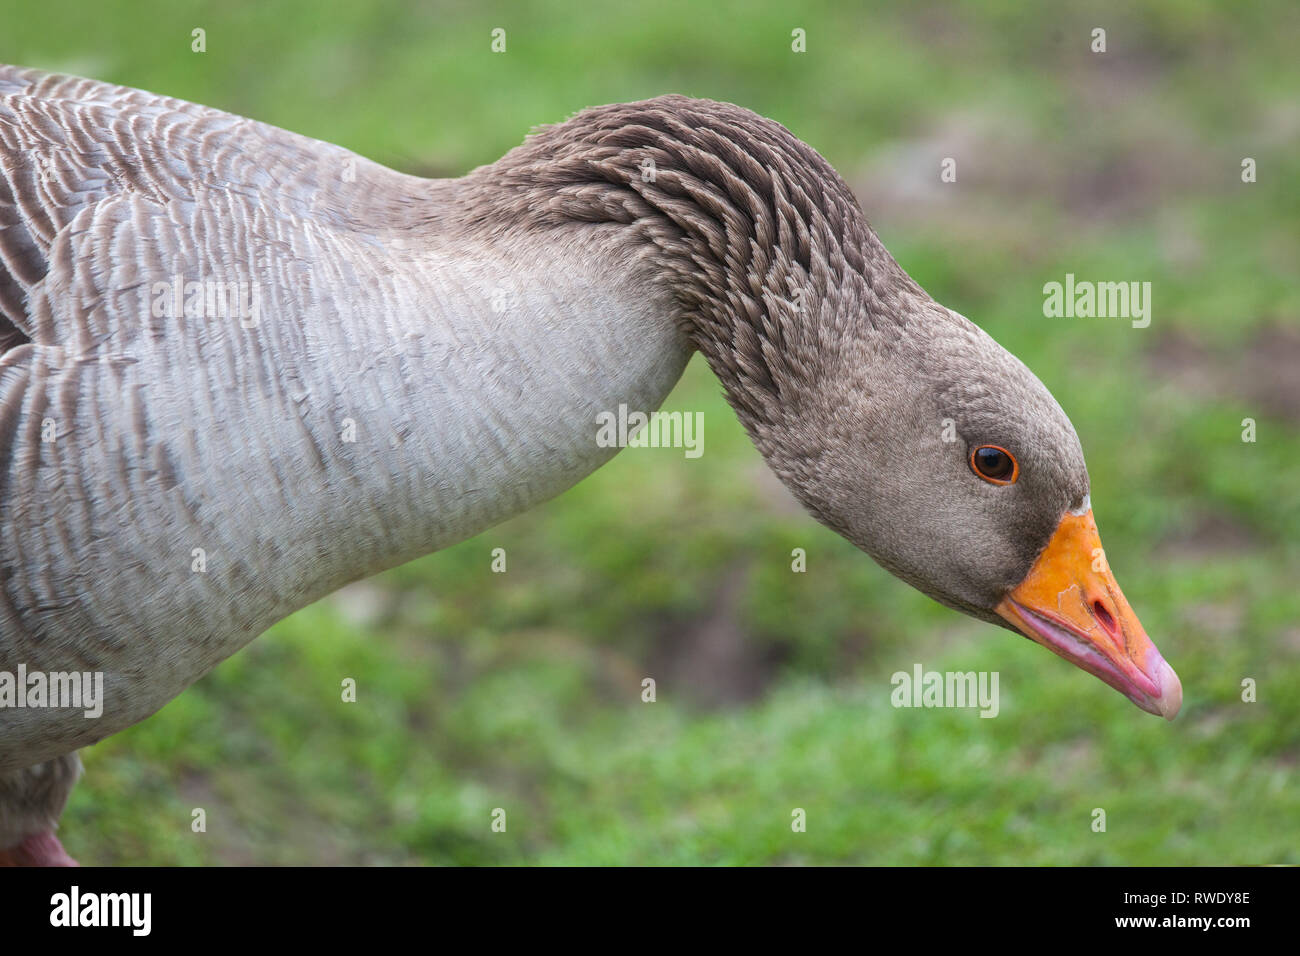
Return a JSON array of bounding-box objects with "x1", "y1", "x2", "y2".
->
[{"x1": 467, "y1": 96, "x2": 1182, "y2": 719}]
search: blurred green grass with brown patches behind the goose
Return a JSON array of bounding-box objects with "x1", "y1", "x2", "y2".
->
[{"x1": 0, "y1": 0, "x2": 1300, "y2": 864}]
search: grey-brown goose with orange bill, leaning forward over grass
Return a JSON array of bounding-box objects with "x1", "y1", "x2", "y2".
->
[{"x1": 0, "y1": 66, "x2": 1182, "y2": 865}]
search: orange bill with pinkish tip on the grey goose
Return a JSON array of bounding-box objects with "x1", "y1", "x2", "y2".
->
[{"x1": 997, "y1": 510, "x2": 1183, "y2": 721}]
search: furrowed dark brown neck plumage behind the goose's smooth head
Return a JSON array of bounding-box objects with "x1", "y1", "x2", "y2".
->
[{"x1": 463, "y1": 95, "x2": 928, "y2": 437}]
